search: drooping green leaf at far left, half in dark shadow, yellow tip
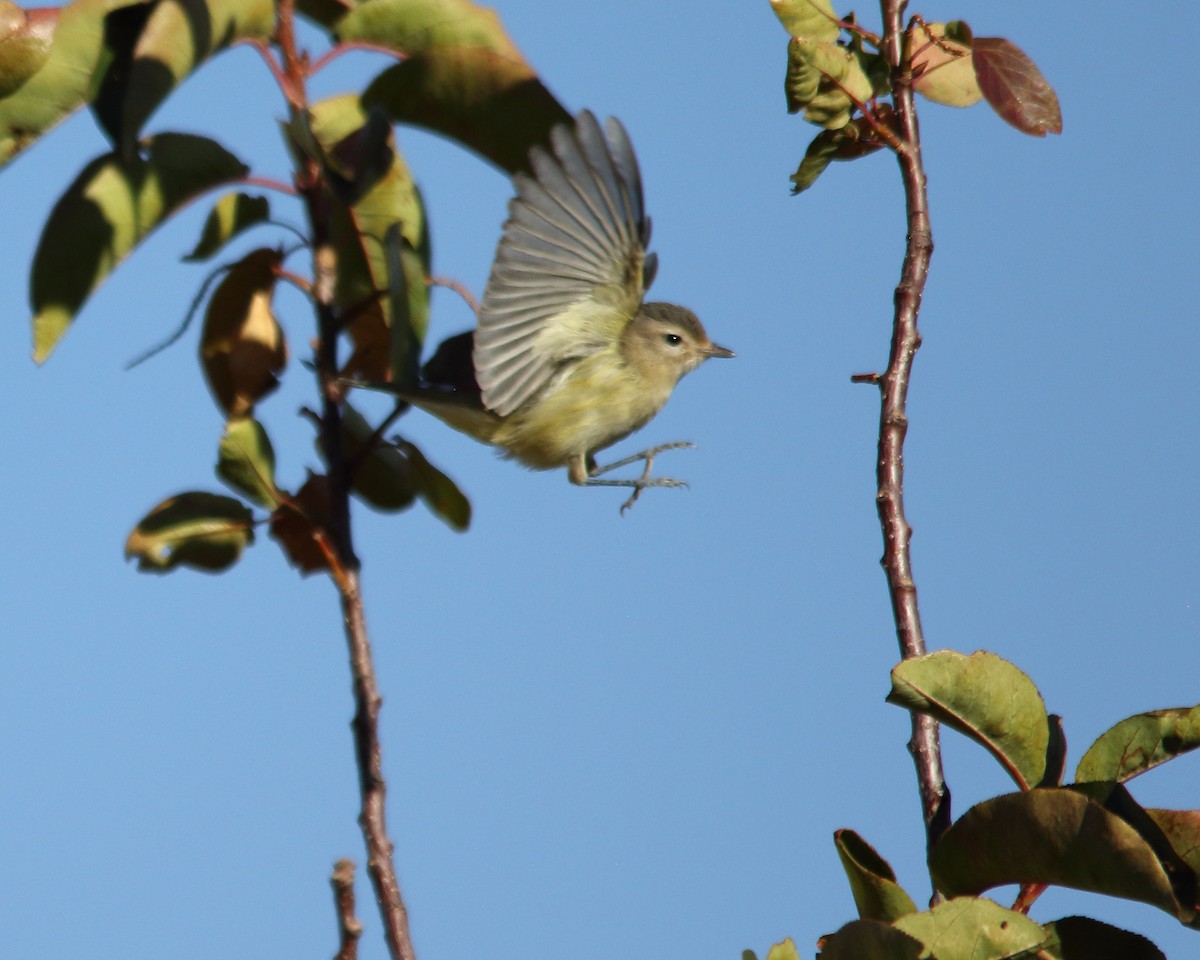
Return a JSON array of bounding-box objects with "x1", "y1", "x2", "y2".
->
[{"x1": 30, "y1": 133, "x2": 246, "y2": 362}]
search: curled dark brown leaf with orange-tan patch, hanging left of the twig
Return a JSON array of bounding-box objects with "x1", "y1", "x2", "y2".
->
[{"x1": 200, "y1": 247, "x2": 288, "y2": 419}]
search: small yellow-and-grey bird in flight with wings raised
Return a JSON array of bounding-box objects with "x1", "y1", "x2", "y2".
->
[{"x1": 360, "y1": 110, "x2": 734, "y2": 514}]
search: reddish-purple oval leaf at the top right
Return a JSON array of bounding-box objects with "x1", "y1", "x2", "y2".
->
[{"x1": 971, "y1": 37, "x2": 1062, "y2": 137}]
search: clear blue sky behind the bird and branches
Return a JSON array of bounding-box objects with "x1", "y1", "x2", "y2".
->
[{"x1": 0, "y1": 0, "x2": 1200, "y2": 960}]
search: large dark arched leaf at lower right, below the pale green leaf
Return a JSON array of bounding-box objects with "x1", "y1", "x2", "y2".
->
[{"x1": 930, "y1": 787, "x2": 1193, "y2": 923}]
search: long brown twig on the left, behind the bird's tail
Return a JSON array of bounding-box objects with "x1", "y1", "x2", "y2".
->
[{"x1": 275, "y1": 0, "x2": 416, "y2": 960}]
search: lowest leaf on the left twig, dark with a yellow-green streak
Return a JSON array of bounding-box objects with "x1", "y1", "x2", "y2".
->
[{"x1": 125, "y1": 492, "x2": 254, "y2": 574}]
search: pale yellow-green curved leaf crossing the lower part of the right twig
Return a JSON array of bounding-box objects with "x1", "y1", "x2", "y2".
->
[{"x1": 888, "y1": 650, "x2": 1050, "y2": 790}]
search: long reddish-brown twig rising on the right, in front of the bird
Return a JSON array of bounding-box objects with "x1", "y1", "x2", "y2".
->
[{"x1": 876, "y1": 0, "x2": 950, "y2": 883}]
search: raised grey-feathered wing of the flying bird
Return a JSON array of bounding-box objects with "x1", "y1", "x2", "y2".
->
[{"x1": 474, "y1": 110, "x2": 655, "y2": 416}]
